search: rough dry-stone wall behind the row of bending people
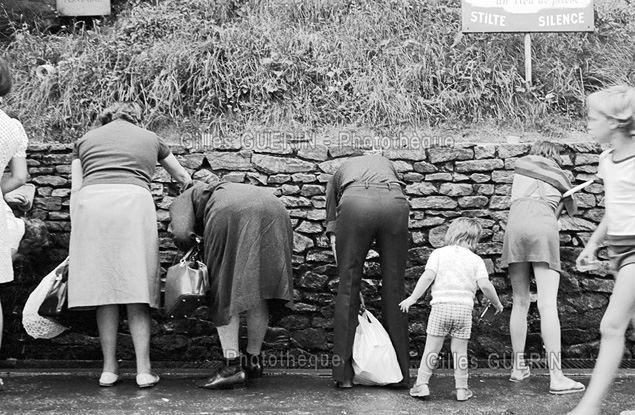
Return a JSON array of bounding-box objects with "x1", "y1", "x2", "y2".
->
[{"x1": 0, "y1": 143, "x2": 635, "y2": 364}]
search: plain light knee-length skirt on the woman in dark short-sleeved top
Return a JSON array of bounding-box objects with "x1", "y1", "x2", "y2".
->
[{"x1": 68, "y1": 184, "x2": 161, "y2": 308}]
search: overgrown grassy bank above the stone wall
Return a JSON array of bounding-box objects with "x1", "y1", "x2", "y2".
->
[{"x1": 0, "y1": 0, "x2": 635, "y2": 142}]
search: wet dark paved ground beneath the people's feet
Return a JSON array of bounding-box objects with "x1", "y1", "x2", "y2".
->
[{"x1": 0, "y1": 369, "x2": 635, "y2": 415}]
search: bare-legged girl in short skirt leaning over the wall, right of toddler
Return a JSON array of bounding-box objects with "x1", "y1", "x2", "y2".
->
[{"x1": 501, "y1": 141, "x2": 584, "y2": 395}]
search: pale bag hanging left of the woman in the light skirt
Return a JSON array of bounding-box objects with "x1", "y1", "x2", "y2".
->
[{"x1": 22, "y1": 258, "x2": 68, "y2": 339}]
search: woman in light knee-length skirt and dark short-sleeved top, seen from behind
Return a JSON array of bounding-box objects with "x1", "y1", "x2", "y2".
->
[{"x1": 68, "y1": 102, "x2": 191, "y2": 388}]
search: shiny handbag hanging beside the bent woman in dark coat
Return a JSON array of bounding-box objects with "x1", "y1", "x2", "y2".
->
[{"x1": 164, "y1": 241, "x2": 210, "y2": 318}]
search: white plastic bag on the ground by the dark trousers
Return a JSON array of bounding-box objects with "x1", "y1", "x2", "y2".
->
[{"x1": 353, "y1": 310, "x2": 403, "y2": 385}]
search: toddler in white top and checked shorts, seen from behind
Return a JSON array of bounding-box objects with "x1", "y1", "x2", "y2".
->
[{"x1": 399, "y1": 218, "x2": 503, "y2": 401}]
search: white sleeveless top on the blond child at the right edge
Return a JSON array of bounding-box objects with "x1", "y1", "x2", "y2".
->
[{"x1": 598, "y1": 149, "x2": 635, "y2": 236}]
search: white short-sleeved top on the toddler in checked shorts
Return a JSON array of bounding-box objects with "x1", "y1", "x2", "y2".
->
[{"x1": 426, "y1": 245, "x2": 489, "y2": 307}]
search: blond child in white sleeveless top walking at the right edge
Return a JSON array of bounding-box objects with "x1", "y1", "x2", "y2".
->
[{"x1": 569, "y1": 85, "x2": 635, "y2": 415}]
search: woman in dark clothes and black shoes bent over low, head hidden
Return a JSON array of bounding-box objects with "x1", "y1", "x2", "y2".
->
[{"x1": 170, "y1": 182, "x2": 293, "y2": 389}]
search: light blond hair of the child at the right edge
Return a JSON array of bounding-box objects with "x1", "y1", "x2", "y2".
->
[{"x1": 586, "y1": 85, "x2": 635, "y2": 135}]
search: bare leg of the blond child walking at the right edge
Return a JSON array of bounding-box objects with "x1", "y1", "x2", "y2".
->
[{"x1": 571, "y1": 264, "x2": 635, "y2": 415}]
